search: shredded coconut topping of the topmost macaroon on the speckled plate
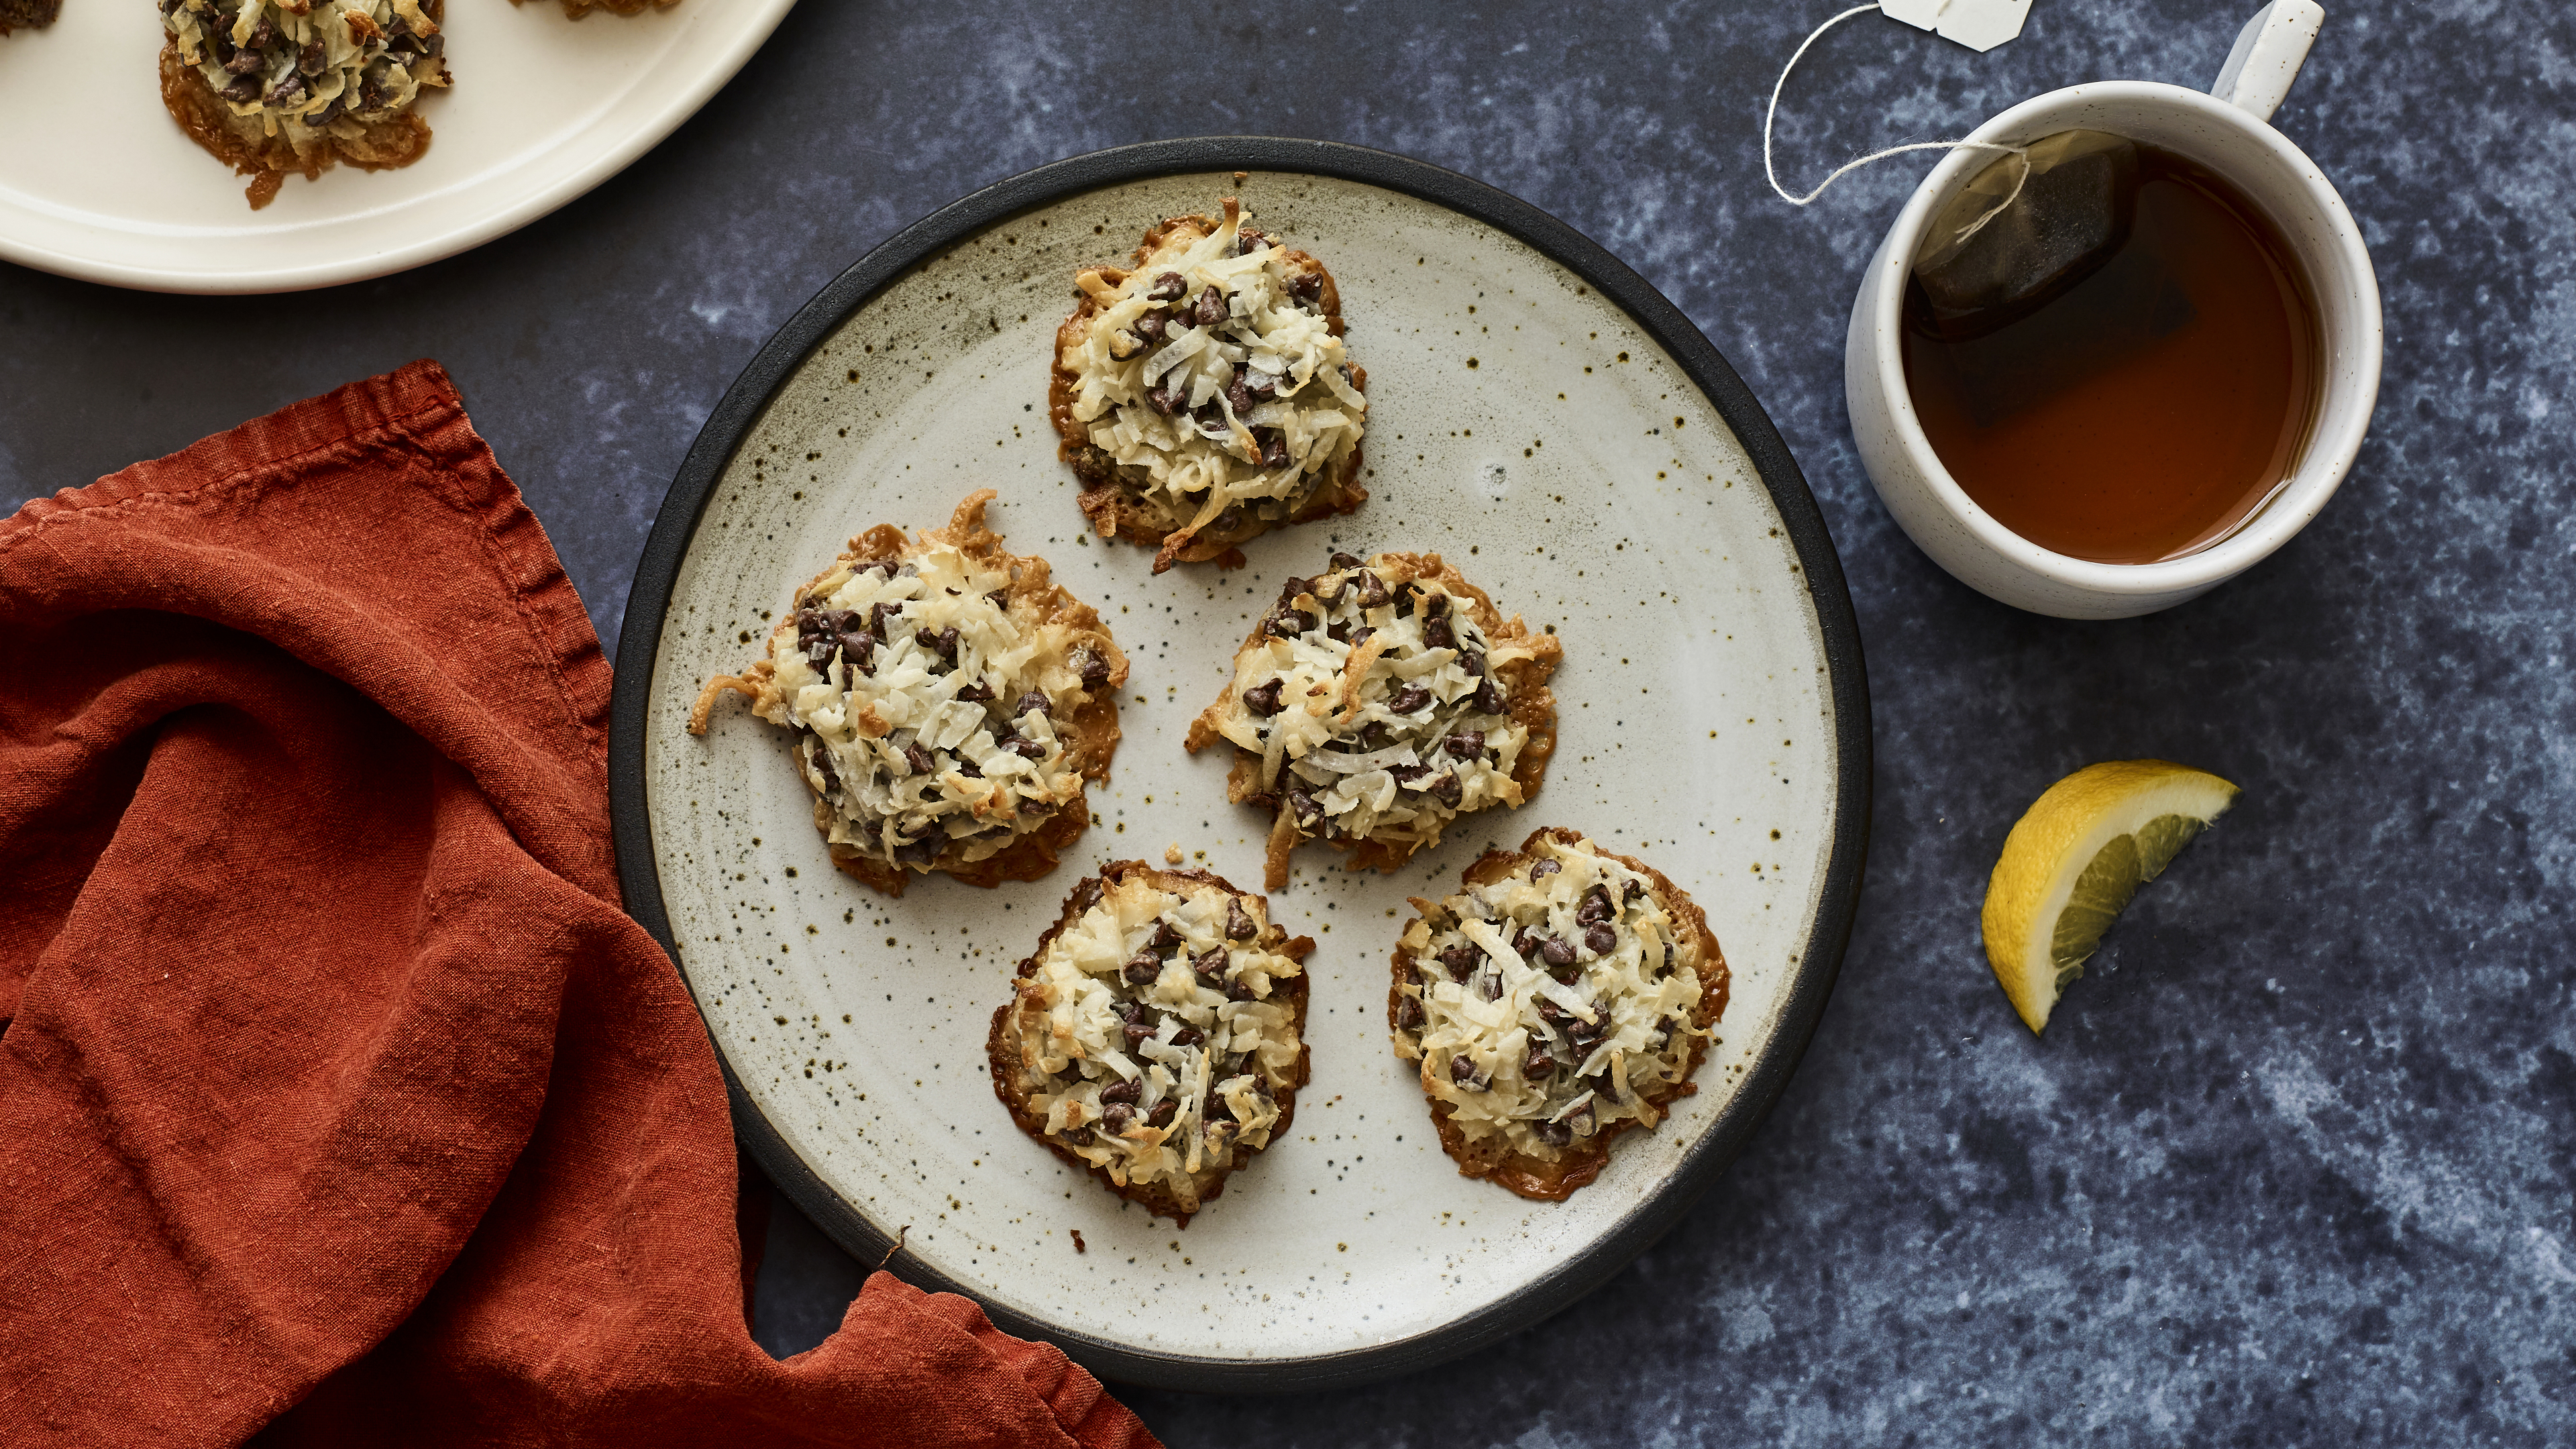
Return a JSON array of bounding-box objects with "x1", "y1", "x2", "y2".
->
[{"x1": 1061, "y1": 199, "x2": 1368, "y2": 534}]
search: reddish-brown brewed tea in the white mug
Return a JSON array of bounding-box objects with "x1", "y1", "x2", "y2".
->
[{"x1": 1904, "y1": 142, "x2": 2324, "y2": 565}]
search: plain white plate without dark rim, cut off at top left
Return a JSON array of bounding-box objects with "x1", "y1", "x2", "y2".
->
[{"x1": 0, "y1": 0, "x2": 796, "y2": 291}]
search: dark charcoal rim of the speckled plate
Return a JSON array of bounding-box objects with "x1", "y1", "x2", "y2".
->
[{"x1": 608, "y1": 137, "x2": 1870, "y2": 1392}]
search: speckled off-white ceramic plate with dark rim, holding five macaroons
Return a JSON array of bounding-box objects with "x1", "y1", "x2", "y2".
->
[{"x1": 613, "y1": 140, "x2": 1870, "y2": 1390}]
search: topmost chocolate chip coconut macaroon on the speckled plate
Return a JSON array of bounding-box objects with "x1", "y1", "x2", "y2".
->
[{"x1": 1046, "y1": 196, "x2": 1368, "y2": 572}]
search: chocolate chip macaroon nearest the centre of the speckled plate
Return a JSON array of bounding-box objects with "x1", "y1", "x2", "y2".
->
[{"x1": 1183, "y1": 554, "x2": 1564, "y2": 890}]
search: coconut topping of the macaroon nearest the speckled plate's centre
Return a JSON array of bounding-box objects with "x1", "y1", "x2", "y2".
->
[{"x1": 1218, "y1": 554, "x2": 1543, "y2": 846}]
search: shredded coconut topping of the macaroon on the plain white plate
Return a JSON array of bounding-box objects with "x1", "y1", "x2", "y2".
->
[{"x1": 160, "y1": 0, "x2": 448, "y2": 137}]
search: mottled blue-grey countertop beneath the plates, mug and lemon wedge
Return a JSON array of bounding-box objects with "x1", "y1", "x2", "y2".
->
[{"x1": 0, "y1": 0, "x2": 2576, "y2": 1449}]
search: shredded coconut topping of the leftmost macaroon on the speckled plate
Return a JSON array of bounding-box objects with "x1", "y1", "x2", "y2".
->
[{"x1": 770, "y1": 533, "x2": 1110, "y2": 871}]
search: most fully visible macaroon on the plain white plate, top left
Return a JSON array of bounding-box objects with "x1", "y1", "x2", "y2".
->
[{"x1": 160, "y1": 0, "x2": 451, "y2": 211}]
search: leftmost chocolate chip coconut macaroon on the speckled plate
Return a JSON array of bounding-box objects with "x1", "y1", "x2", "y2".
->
[{"x1": 688, "y1": 487, "x2": 1126, "y2": 895}]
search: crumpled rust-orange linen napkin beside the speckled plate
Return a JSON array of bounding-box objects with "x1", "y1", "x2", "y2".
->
[{"x1": 0, "y1": 364, "x2": 1151, "y2": 1446}]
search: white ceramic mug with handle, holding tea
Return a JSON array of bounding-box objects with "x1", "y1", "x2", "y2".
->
[{"x1": 1842, "y1": 0, "x2": 2380, "y2": 619}]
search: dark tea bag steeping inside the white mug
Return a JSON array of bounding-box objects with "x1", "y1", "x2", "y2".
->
[{"x1": 1914, "y1": 131, "x2": 2138, "y2": 340}]
